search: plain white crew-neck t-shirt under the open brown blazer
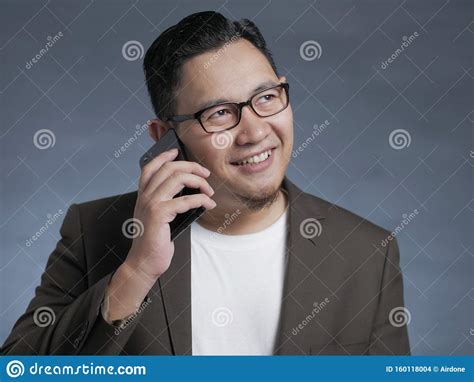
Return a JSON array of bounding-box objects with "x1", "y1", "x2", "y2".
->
[{"x1": 191, "y1": 209, "x2": 288, "y2": 355}]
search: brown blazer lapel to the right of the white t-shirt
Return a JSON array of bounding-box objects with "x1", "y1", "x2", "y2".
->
[{"x1": 274, "y1": 177, "x2": 331, "y2": 355}]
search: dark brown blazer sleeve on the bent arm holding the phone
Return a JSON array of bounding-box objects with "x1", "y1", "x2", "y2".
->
[{"x1": 0, "y1": 204, "x2": 143, "y2": 355}]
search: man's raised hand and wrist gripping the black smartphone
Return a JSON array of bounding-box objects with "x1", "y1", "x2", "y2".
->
[{"x1": 125, "y1": 150, "x2": 216, "y2": 281}]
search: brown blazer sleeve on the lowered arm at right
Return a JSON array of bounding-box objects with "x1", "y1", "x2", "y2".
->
[{"x1": 369, "y1": 238, "x2": 410, "y2": 355}]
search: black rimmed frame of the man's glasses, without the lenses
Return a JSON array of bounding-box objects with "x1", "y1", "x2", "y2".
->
[{"x1": 163, "y1": 82, "x2": 290, "y2": 134}]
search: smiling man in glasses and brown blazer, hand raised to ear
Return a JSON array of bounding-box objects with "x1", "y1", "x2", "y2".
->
[{"x1": 2, "y1": 12, "x2": 410, "y2": 355}]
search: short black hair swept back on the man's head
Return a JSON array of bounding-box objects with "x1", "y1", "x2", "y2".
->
[{"x1": 143, "y1": 11, "x2": 278, "y2": 118}]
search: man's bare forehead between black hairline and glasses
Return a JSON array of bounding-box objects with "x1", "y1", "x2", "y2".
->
[{"x1": 177, "y1": 39, "x2": 278, "y2": 112}]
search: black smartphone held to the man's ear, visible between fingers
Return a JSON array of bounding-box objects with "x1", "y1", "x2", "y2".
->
[{"x1": 140, "y1": 129, "x2": 205, "y2": 240}]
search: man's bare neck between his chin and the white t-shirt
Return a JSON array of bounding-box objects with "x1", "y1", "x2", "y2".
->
[{"x1": 198, "y1": 188, "x2": 288, "y2": 235}]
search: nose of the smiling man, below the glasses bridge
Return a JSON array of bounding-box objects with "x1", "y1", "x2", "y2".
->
[{"x1": 234, "y1": 106, "x2": 271, "y2": 145}]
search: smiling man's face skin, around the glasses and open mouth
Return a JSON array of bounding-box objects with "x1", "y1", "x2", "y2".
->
[{"x1": 176, "y1": 39, "x2": 293, "y2": 209}]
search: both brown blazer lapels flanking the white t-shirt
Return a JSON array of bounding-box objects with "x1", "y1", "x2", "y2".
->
[{"x1": 153, "y1": 177, "x2": 327, "y2": 355}]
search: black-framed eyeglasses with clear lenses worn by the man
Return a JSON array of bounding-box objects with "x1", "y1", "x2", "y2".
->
[{"x1": 164, "y1": 83, "x2": 290, "y2": 133}]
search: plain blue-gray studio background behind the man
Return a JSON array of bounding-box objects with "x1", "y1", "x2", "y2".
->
[{"x1": 0, "y1": 0, "x2": 474, "y2": 354}]
